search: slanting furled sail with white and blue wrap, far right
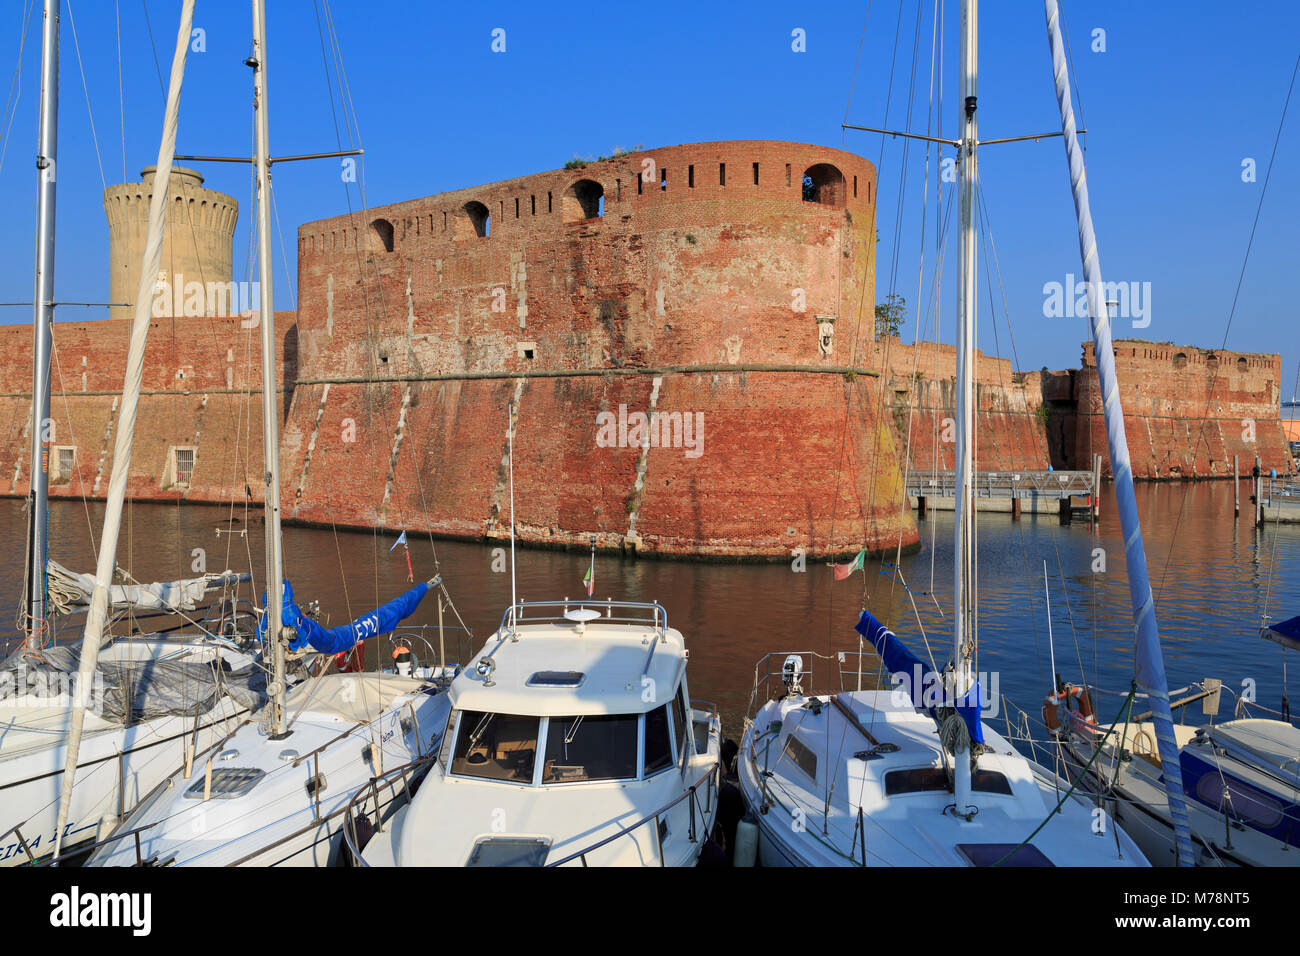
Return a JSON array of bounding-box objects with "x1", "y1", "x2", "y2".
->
[{"x1": 1043, "y1": 0, "x2": 1196, "y2": 866}]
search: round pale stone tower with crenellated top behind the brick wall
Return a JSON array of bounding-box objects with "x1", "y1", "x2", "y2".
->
[{"x1": 104, "y1": 166, "x2": 239, "y2": 319}]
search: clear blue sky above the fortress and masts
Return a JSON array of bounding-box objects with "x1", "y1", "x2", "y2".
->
[{"x1": 0, "y1": 0, "x2": 1300, "y2": 398}]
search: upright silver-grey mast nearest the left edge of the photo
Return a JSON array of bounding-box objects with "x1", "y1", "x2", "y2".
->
[{"x1": 25, "y1": 0, "x2": 59, "y2": 649}]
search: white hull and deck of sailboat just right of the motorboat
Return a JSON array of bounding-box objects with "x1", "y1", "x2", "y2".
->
[{"x1": 737, "y1": 692, "x2": 1147, "y2": 866}]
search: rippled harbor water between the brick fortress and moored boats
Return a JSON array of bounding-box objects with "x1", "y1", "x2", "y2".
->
[{"x1": 0, "y1": 481, "x2": 1300, "y2": 739}]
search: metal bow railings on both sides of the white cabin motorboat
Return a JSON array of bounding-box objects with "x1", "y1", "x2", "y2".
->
[{"x1": 343, "y1": 754, "x2": 719, "y2": 868}]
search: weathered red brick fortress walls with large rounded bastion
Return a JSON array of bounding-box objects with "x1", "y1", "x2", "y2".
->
[{"x1": 0, "y1": 140, "x2": 1288, "y2": 557}]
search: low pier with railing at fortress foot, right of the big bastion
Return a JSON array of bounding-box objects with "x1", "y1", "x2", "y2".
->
[{"x1": 906, "y1": 455, "x2": 1102, "y2": 522}]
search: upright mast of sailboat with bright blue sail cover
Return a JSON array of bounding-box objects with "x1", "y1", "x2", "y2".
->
[{"x1": 247, "y1": 0, "x2": 289, "y2": 740}]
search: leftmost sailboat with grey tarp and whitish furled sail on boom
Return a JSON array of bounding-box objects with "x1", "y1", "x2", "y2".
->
[{"x1": 0, "y1": 0, "x2": 265, "y2": 866}]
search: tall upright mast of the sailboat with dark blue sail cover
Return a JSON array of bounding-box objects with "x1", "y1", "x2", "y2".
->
[{"x1": 953, "y1": 0, "x2": 979, "y2": 816}]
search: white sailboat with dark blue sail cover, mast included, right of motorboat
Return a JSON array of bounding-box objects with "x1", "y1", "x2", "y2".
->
[{"x1": 738, "y1": 0, "x2": 1180, "y2": 866}]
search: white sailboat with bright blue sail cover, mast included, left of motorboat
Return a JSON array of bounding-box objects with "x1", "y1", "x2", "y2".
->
[{"x1": 60, "y1": 0, "x2": 449, "y2": 866}]
